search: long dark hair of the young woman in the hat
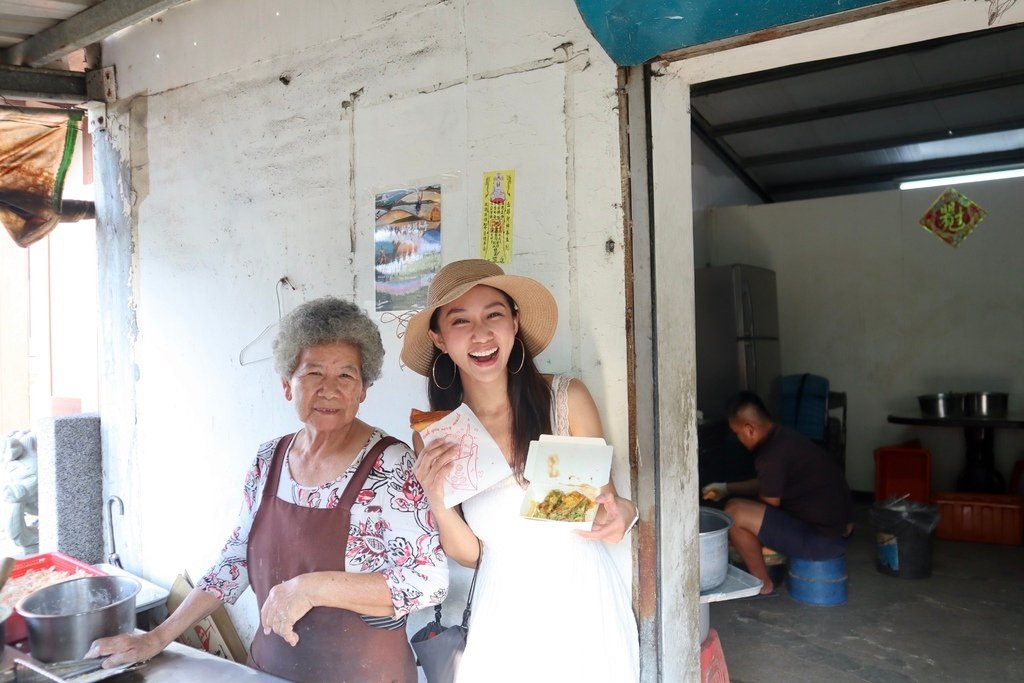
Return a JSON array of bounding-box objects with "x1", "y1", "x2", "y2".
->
[{"x1": 427, "y1": 299, "x2": 551, "y2": 482}]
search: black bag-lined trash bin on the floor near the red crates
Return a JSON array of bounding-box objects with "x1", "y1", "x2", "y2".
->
[{"x1": 870, "y1": 498, "x2": 939, "y2": 579}]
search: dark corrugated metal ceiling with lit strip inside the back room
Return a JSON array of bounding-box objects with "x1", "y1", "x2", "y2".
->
[{"x1": 691, "y1": 26, "x2": 1024, "y2": 201}]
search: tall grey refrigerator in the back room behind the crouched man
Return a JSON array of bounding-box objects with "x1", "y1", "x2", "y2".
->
[{"x1": 694, "y1": 264, "x2": 781, "y2": 421}]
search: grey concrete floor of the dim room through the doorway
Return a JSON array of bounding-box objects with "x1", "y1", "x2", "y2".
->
[{"x1": 710, "y1": 504, "x2": 1024, "y2": 683}]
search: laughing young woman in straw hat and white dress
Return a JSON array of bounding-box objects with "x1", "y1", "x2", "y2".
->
[{"x1": 401, "y1": 259, "x2": 639, "y2": 683}]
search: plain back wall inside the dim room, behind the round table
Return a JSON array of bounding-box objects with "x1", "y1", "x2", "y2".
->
[{"x1": 710, "y1": 179, "x2": 1024, "y2": 490}]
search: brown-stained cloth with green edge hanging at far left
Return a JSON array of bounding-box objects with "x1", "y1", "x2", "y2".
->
[{"x1": 0, "y1": 110, "x2": 82, "y2": 247}]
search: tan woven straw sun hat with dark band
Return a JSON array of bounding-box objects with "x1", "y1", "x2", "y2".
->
[{"x1": 401, "y1": 258, "x2": 558, "y2": 376}]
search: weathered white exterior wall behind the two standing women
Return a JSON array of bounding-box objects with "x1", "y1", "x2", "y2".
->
[{"x1": 103, "y1": 0, "x2": 630, "y2": 651}]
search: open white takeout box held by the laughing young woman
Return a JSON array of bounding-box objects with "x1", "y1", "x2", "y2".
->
[{"x1": 519, "y1": 434, "x2": 612, "y2": 530}]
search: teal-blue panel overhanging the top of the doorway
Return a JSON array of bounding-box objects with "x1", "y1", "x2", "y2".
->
[{"x1": 577, "y1": 0, "x2": 885, "y2": 67}]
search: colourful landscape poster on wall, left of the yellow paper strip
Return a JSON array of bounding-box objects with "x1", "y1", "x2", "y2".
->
[{"x1": 374, "y1": 184, "x2": 441, "y2": 310}]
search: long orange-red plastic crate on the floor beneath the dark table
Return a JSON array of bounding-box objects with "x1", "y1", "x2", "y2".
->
[{"x1": 935, "y1": 494, "x2": 1024, "y2": 546}]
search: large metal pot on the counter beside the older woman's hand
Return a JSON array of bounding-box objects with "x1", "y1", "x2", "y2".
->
[{"x1": 16, "y1": 577, "x2": 139, "y2": 661}]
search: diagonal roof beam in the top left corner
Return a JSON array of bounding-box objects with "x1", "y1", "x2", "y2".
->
[{"x1": 0, "y1": 0, "x2": 187, "y2": 67}]
